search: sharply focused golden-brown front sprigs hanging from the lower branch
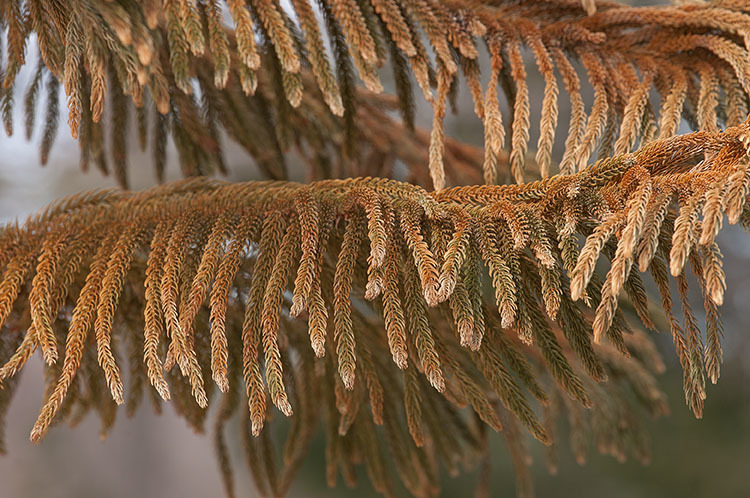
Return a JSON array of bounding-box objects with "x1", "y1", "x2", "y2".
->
[{"x1": 0, "y1": 120, "x2": 749, "y2": 456}]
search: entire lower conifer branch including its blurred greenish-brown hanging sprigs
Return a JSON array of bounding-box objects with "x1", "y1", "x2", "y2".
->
[{"x1": 0, "y1": 123, "x2": 750, "y2": 495}]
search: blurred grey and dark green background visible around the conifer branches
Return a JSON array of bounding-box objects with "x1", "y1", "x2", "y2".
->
[{"x1": 0, "y1": 4, "x2": 750, "y2": 498}]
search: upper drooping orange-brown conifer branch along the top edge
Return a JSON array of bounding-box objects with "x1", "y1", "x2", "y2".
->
[{"x1": 0, "y1": 0, "x2": 750, "y2": 190}]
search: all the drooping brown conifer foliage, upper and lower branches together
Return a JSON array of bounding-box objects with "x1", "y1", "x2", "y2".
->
[{"x1": 0, "y1": 0, "x2": 750, "y2": 496}]
